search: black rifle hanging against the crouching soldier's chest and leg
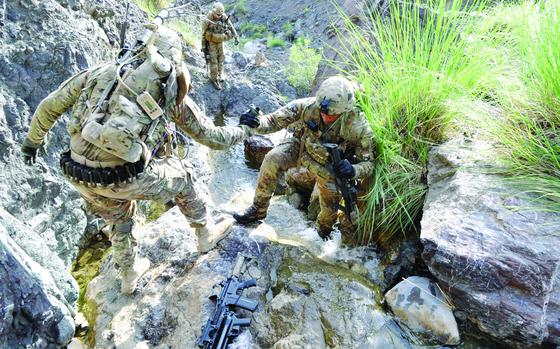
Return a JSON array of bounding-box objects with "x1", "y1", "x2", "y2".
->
[{"x1": 323, "y1": 143, "x2": 358, "y2": 223}]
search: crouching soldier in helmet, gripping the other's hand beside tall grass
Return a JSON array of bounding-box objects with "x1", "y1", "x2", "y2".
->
[{"x1": 233, "y1": 76, "x2": 375, "y2": 238}]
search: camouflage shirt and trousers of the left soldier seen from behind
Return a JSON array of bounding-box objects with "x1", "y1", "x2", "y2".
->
[{"x1": 24, "y1": 27, "x2": 252, "y2": 269}]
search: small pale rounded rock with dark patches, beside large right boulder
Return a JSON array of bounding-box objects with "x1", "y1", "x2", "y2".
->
[{"x1": 385, "y1": 276, "x2": 461, "y2": 345}]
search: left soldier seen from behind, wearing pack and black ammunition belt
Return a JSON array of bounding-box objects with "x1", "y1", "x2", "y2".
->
[{"x1": 22, "y1": 27, "x2": 252, "y2": 294}]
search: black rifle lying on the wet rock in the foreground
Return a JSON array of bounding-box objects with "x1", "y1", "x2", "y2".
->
[{"x1": 197, "y1": 255, "x2": 258, "y2": 349}]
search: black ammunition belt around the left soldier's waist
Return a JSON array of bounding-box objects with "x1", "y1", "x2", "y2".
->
[{"x1": 60, "y1": 151, "x2": 145, "y2": 186}]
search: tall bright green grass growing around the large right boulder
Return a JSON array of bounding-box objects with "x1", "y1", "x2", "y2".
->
[{"x1": 340, "y1": 0, "x2": 560, "y2": 243}]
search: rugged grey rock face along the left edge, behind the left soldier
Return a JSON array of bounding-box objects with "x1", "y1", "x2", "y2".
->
[{"x1": 0, "y1": 0, "x2": 147, "y2": 348}]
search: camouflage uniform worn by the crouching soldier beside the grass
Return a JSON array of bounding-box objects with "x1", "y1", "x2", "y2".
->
[{"x1": 236, "y1": 77, "x2": 374, "y2": 233}]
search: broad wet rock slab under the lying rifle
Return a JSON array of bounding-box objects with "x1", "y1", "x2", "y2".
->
[{"x1": 87, "y1": 208, "x2": 424, "y2": 349}]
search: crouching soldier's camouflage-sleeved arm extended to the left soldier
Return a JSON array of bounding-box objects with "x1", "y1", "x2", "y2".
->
[{"x1": 255, "y1": 98, "x2": 310, "y2": 134}]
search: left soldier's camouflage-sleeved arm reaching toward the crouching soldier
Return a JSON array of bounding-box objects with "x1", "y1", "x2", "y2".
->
[{"x1": 171, "y1": 96, "x2": 254, "y2": 150}]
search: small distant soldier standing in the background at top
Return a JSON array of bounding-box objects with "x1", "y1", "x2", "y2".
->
[{"x1": 202, "y1": 2, "x2": 239, "y2": 90}]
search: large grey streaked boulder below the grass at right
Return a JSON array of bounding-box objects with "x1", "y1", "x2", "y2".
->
[{"x1": 421, "y1": 140, "x2": 560, "y2": 348}]
